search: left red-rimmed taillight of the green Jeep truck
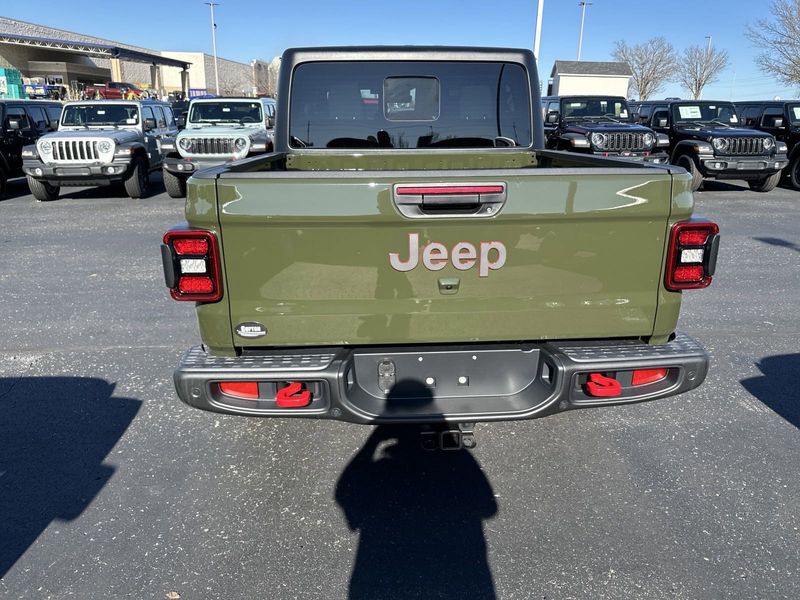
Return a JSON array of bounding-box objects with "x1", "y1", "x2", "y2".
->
[{"x1": 162, "y1": 229, "x2": 222, "y2": 302}]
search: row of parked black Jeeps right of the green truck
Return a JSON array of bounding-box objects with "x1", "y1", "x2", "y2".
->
[{"x1": 542, "y1": 96, "x2": 800, "y2": 192}]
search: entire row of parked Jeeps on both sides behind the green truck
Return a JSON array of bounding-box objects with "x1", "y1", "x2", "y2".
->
[{"x1": 0, "y1": 95, "x2": 800, "y2": 200}]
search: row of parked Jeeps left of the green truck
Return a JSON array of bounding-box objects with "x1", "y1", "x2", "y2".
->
[{"x1": 0, "y1": 98, "x2": 275, "y2": 201}]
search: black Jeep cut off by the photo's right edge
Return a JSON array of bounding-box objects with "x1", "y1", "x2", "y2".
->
[{"x1": 734, "y1": 100, "x2": 800, "y2": 190}]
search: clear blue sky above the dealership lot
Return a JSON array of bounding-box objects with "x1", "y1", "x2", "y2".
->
[{"x1": 2, "y1": 0, "x2": 798, "y2": 100}]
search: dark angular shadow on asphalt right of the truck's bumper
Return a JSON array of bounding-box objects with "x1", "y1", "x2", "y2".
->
[{"x1": 741, "y1": 354, "x2": 800, "y2": 428}]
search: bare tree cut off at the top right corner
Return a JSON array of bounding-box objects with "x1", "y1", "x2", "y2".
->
[{"x1": 746, "y1": 0, "x2": 800, "y2": 85}]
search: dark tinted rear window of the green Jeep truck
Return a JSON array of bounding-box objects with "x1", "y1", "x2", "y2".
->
[{"x1": 289, "y1": 61, "x2": 532, "y2": 150}]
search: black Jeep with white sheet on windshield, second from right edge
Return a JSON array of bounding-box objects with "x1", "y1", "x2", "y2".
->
[{"x1": 637, "y1": 100, "x2": 789, "y2": 192}]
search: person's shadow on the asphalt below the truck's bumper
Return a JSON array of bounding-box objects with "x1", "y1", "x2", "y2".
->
[{"x1": 336, "y1": 382, "x2": 497, "y2": 600}]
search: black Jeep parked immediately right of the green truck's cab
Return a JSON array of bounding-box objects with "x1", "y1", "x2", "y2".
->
[{"x1": 542, "y1": 96, "x2": 669, "y2": 163}]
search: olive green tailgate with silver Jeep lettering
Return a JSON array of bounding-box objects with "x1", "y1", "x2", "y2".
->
[{"x1": 212, "y1": 168, "x2": 672, "y2": 347}]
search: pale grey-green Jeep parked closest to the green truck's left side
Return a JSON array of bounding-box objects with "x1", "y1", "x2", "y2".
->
[{"x1": 161, "y1": 98, "x2": 275, "y2": 198}]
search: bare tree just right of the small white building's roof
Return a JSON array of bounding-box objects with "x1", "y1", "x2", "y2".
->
[{"x1": 613, "y1": 37, "x2": 676, "y2": 100}]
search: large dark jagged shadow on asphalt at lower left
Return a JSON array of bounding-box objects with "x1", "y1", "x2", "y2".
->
[{"x1": 0, "y1": 377, "x2": 142, "y2": 577}]
